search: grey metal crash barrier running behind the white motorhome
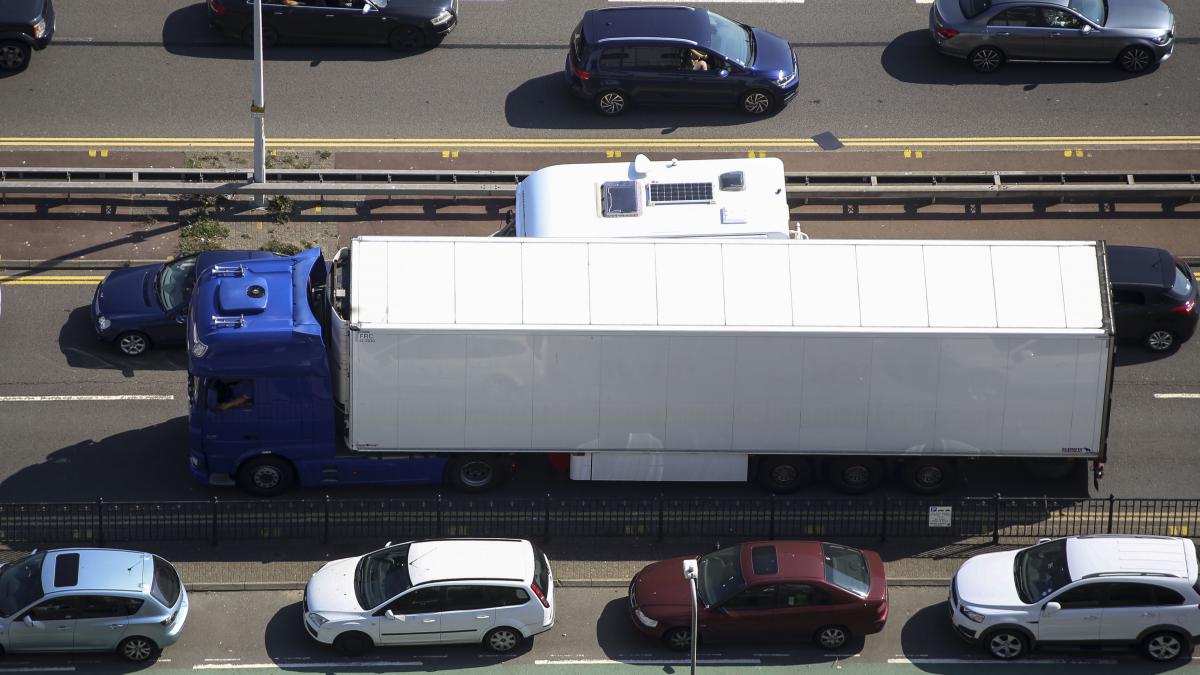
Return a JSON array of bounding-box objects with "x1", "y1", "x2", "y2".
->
[{"x1": 0, "y1": 167, "x2": 1200, "y2": 202}]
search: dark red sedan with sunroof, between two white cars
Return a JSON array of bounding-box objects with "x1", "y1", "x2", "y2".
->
[{"x1": 629, "y1": 542, "x2": 888, "y2": 651}]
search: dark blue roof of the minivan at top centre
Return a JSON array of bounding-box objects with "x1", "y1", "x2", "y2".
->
[{"x1": 583, "y1": 5, "x2": 709, "y2": 46}]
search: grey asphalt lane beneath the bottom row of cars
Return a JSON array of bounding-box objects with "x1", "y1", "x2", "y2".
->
[{"x1": 0, "y1": 579, "x2": 1188, "y2": 675}]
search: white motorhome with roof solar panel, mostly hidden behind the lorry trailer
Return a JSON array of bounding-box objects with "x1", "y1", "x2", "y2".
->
[{"x1": 510, "y1": 155, "x2": 788, "y2": 239}]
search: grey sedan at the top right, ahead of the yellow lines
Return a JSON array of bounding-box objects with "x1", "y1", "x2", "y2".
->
[{"x1": 929, "y1": 0, "x2": 1175, "y2": 73}]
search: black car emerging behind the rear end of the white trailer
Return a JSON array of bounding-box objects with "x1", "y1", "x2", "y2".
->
[{"x1": 1108, "y1": 246, "x2": 1200, "y2": 352}]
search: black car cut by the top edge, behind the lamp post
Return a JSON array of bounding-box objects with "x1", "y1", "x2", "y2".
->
[{"x1": 208, "y1": 0, "x2": 458, "y2": 52}]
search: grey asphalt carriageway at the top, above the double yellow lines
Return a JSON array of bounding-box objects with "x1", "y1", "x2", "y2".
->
[{"x1": 0, "y1": 0, "x2": 1200, "y2": 141}]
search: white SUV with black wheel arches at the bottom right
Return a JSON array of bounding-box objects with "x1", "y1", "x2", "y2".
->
[{"x1": 950, "y1": 534, "x2": 1200, "y2": 662}]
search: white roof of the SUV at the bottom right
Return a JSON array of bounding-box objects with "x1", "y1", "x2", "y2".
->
[{"x1": 1067, "y1": 536, "x2": 1196, "y2": 583}]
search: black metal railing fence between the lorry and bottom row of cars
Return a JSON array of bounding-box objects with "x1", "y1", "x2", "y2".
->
[{"x1": 0, "y1": 495, "x2": 1200, "y2": 549}]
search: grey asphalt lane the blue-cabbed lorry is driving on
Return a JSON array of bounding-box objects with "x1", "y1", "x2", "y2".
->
[{"x1": 0, "y1": 276, "x2": 1200, "y2": 501}]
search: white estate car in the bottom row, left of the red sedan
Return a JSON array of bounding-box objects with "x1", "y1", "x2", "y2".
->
[{"x1": 302, "y1": 539, "x2": 554, "y2": 656}]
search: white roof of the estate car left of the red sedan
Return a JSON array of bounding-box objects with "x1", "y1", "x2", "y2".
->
[{"x1": 408, "y1": 539, "x2": 534, "y2": 586}]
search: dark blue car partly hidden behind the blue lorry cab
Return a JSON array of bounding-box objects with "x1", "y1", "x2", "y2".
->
[{"x1": 91, "y1": 251, "x2": 276, "y2": 357}]
